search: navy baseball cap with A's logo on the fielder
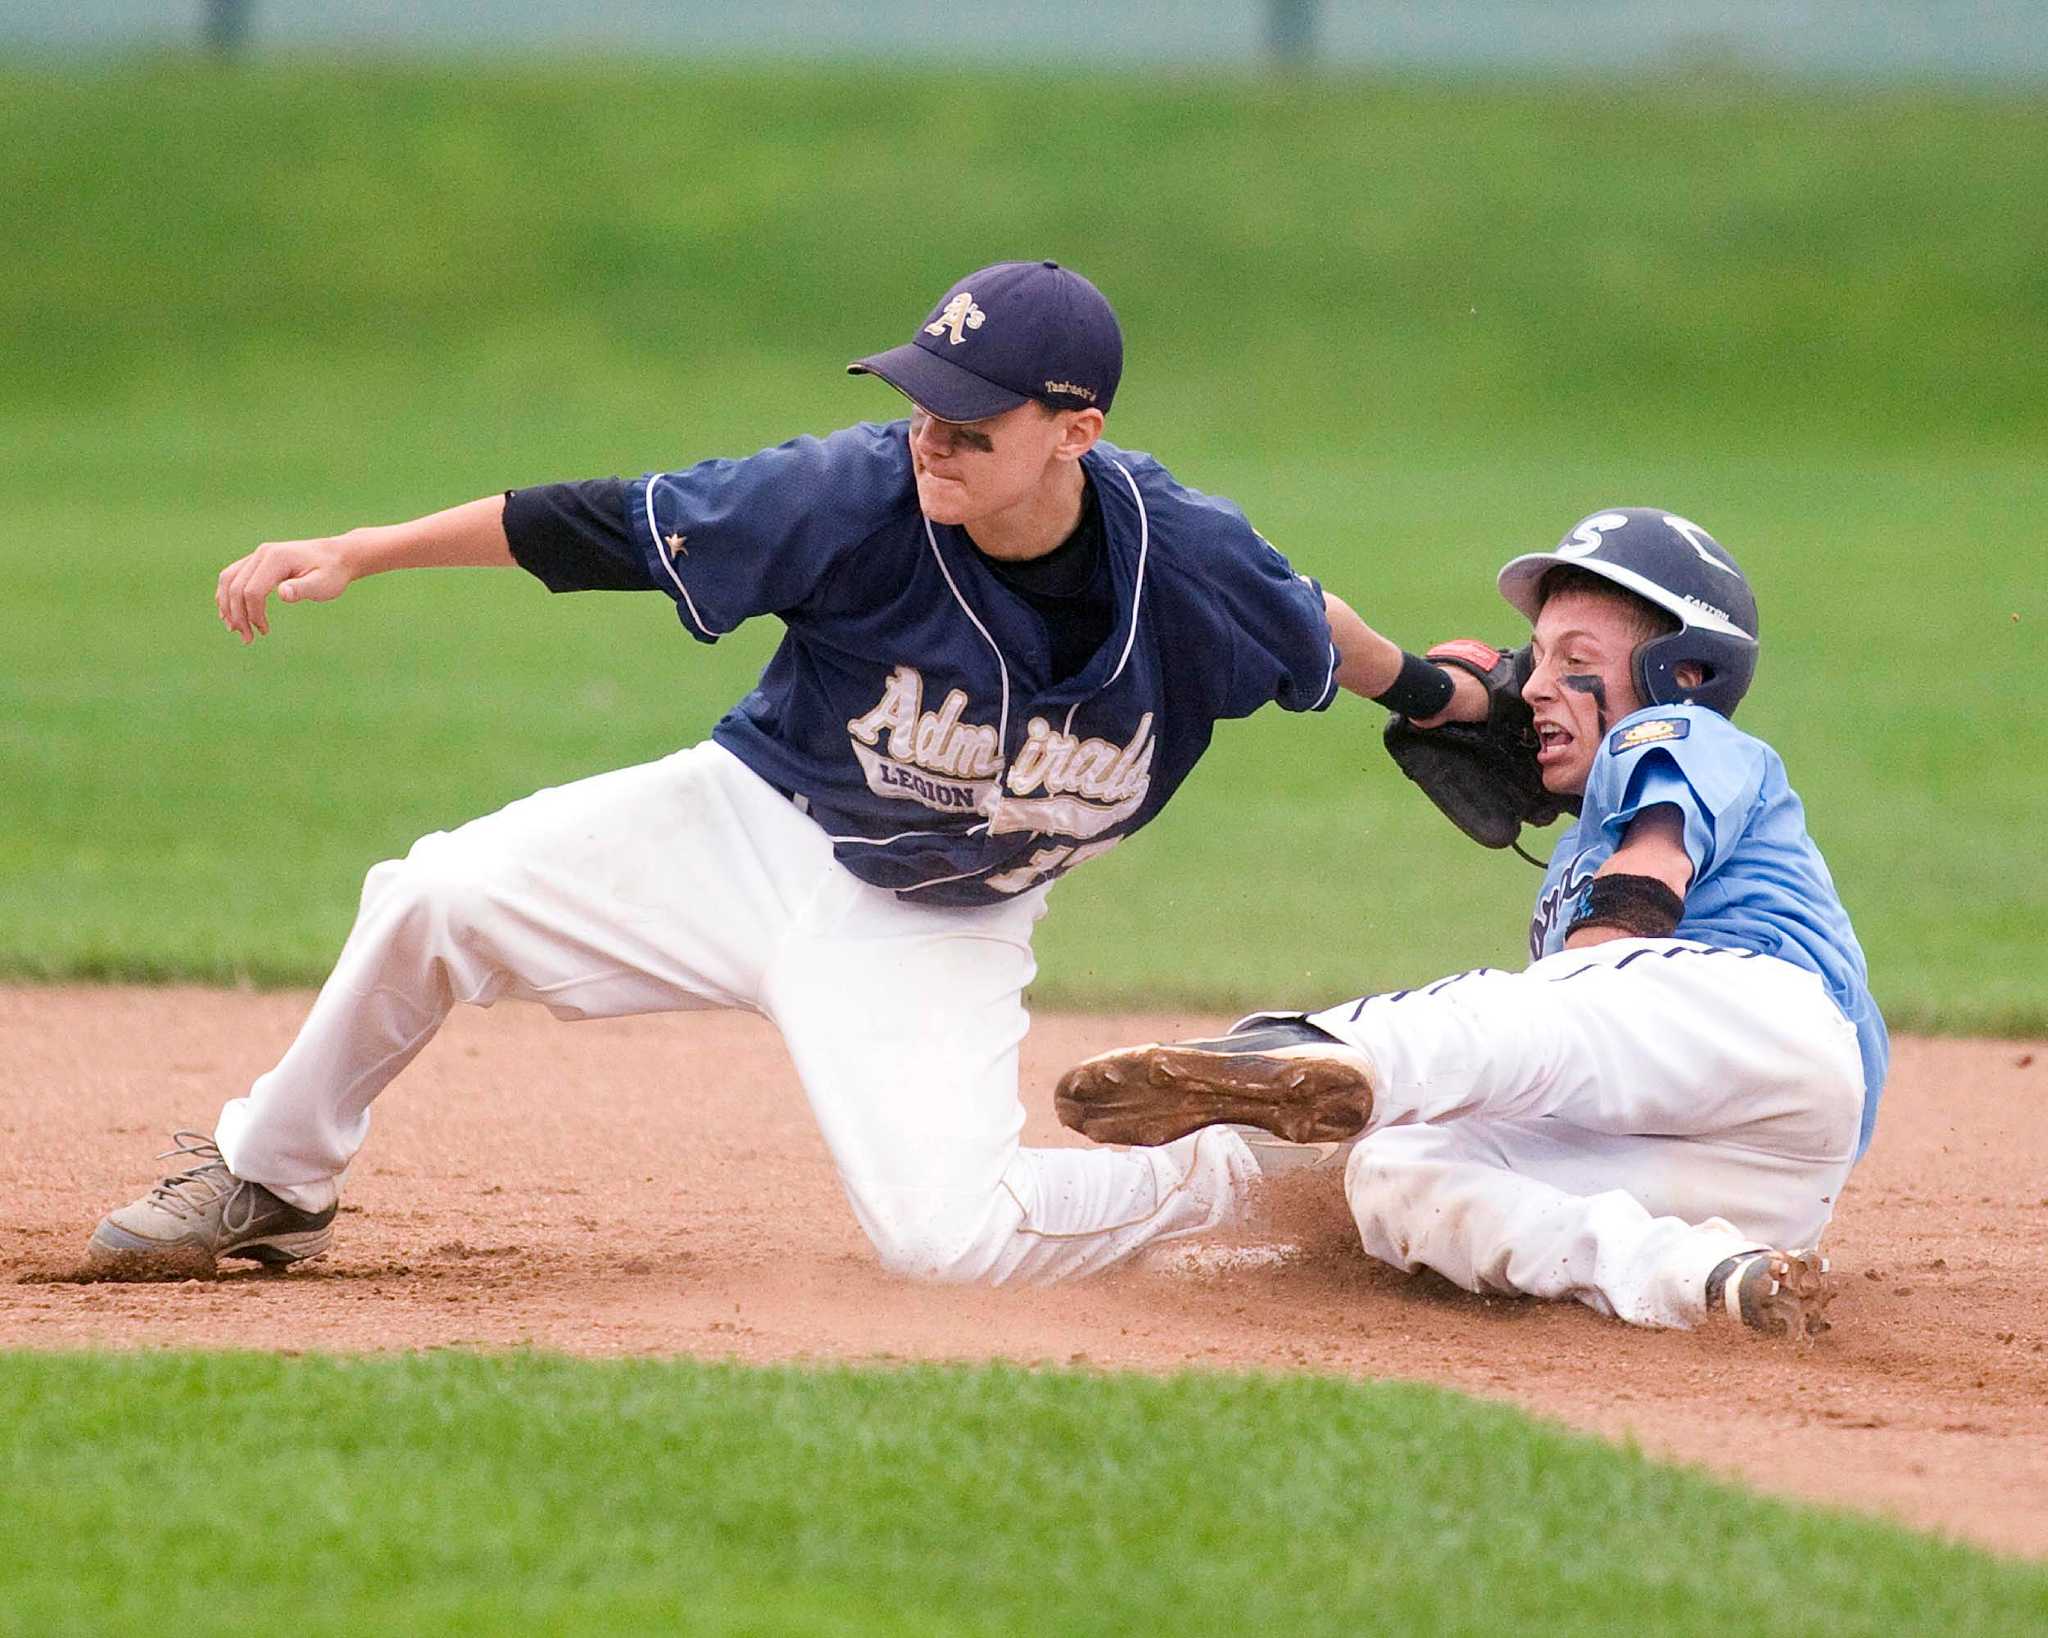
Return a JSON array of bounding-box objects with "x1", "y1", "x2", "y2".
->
[{"x1": 846, "y1": 262, "x2": 1124, "y2": 422}]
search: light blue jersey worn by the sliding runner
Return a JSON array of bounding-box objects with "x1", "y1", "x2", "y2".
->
[{"x1": 1530, "y1": 704, "x2": 1890, "y2": 1155}]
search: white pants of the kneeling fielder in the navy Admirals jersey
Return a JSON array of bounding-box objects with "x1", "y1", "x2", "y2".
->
[{"x1": 215, "y1": 743, "x2": 1257, "y2": 1282}]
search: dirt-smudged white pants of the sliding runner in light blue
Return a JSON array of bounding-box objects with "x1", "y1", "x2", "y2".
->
[{"x1": 1313, "y1": 938, "x2": 1864, "y2": 1327}]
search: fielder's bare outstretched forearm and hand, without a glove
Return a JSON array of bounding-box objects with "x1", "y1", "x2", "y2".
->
[{"x1": 213, "y1": 495, "x2": 516, "y2": 643}]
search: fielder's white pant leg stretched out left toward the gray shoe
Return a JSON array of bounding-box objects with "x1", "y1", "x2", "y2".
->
[{"x1": 215, "y1": 743, "x2": 829, "y2": 1210}]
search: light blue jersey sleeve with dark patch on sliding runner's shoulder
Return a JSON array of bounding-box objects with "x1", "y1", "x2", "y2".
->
[{"x1": 1585, "y1": 706, "x2": 1767, "y2": 882}]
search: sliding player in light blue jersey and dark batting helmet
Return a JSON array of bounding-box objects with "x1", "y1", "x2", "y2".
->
[{"x1": 1057, "y1": 508, "x2": 1888, "y2": 1337}]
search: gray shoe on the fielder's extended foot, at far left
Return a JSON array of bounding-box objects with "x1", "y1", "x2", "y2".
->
[{"x1": 90, "y1": 1132, "x2": 336, "y2": 1269}]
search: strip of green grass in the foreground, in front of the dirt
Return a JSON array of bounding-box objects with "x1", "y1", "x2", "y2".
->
[{"x1": 0, "y1": 1355, "x2": 2048, "y2": 1638}]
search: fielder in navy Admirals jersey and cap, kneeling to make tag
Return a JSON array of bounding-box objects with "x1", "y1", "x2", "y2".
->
[{"x1": 92, "y1": 262, "x2": 1490, "y2": 1280}]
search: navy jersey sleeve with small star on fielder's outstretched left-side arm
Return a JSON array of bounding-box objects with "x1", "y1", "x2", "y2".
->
[{"x1": 625, "y1": 426, "x2": 909, "y2": 643}]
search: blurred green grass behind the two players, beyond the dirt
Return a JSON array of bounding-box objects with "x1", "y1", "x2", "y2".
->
[{"x1": 0, "y1": 70, "x2": 2048, "y2": 1034}]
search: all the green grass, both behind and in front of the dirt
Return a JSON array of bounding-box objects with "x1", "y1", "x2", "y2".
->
[{"x1": 0, "y1": 59, "x2": 2048, "y2": 1634}]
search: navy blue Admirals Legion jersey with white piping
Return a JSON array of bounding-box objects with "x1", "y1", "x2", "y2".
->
[{"x1": 537, "y1": 422, "x2": 1337, "y2": 905}]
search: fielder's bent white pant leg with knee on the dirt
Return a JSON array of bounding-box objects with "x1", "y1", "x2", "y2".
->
[{"x1": 766, "y1": 870, "x2": 1257, "y2": 1282}]
